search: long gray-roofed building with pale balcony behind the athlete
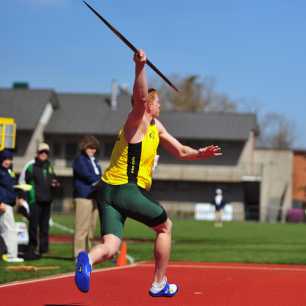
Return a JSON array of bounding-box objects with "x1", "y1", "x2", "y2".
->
[{"x1": 0, "y1": 84, "x2": 291, "y2": 221}]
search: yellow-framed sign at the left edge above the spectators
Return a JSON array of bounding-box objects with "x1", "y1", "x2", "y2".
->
[{"x1": 0, "y1": 117, "x2": 16, "y2": 151}]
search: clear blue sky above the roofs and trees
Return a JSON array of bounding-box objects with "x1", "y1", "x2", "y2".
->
[{"x1": 0, "y1": 0, "x2": 306, "y2": 149}]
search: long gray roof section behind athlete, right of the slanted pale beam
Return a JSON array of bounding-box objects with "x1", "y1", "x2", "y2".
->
[{"x1": 45, "y1": 94, "x2": 257, "y2": 140}]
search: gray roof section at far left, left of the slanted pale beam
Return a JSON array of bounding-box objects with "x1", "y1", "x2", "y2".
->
[{"x1": 0, "y1": 88, "x2": 57, "y2": 130}]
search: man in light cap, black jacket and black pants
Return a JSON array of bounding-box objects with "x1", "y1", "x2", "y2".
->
[{"x1": 19, "y1": 143, "x2": 59, "y2": 257}]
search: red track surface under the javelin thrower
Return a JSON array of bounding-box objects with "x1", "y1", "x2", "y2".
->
[{"x1": 0, "y1": 263, "x2": 306, "y2": 306}]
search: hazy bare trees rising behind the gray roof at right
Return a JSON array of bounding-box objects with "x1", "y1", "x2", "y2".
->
[{"x1": 154, "y1": 75, "x2": 295, "y2": 149}]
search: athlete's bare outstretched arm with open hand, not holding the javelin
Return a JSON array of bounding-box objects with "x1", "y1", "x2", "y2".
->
[{"x1": 156, "y1": 120, "x2": 222, "y2": 160}]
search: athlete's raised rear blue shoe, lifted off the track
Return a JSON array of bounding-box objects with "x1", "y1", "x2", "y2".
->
[{"x1": 74, "y1": 251, "x2": 91, "y2": 292}]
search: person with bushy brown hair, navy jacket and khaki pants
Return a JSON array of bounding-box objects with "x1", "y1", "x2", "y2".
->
[{"x1": 73, "y1": 136, "x2": 101, "y2": 257}]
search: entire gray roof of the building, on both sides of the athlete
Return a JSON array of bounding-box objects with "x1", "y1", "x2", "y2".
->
[{"x1": 0, "y1": 89, "x2": 257, "y2": 141}]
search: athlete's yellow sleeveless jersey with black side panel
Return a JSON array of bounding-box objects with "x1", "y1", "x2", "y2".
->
[{"x1": 102, "y1": 120, "x2": 159, "y2": 190}]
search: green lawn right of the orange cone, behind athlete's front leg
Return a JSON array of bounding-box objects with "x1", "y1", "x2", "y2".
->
[{"x1": 126, "y1": 220, "x2": 306, "y2": 264}]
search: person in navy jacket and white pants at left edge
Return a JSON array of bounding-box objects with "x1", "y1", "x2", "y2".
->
[{"x1": 0, "y1": 150, "x2": 23, "y2": 262}]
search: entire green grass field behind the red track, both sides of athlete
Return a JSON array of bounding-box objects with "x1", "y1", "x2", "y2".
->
[{"x1": 0, "y1": 215, "x2": 306, "y2": 283}]
